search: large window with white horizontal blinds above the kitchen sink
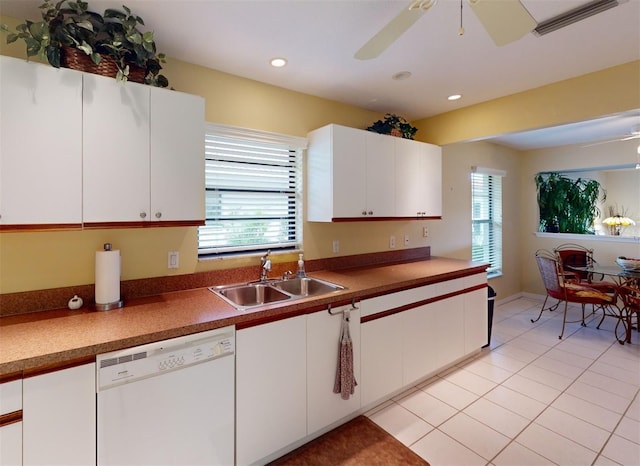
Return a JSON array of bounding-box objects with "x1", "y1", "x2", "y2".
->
[{"x1": 198, "y1": 124, "x2": 306, "y2": 256}]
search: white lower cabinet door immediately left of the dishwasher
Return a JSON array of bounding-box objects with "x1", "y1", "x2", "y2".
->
[{"x1": 23, "y1": 363, "x2": 96, "y2": 466}]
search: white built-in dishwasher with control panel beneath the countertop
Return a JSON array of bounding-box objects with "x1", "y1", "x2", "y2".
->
[{"x1": 96, "y1": 326, "x2": 235, "y2": 466}]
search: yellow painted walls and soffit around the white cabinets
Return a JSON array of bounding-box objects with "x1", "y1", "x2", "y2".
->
[{"x1": 0, "y1": 13, "x2": 640, "y2": 297}]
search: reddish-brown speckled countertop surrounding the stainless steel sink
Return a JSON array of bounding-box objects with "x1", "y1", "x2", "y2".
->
[{"x1": 0, "y1": 257, "x2": 486, "y2": 376}]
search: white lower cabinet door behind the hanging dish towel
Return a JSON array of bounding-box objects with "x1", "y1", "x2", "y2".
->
[{"x1": 307, "y1": 305, "x2": 362, "y2": 434}]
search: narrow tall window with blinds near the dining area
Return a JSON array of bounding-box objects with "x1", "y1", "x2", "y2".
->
[{"x1": 471, "y1": 167, "x2": 504, "y2": 277}]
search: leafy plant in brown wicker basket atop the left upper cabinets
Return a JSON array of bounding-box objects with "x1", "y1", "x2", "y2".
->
[{"x1": 1, "y1": 0, "x2": 169, "y2": 87}]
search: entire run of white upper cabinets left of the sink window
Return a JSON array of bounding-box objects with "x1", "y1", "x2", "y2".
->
[{"x1": 0, "y1": 56, "x2": 205, "y2": 230}]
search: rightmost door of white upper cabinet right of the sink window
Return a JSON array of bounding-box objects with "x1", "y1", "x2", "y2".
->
[{"x1": 394, "y1": 138, "x2": 442, "y2": 217}]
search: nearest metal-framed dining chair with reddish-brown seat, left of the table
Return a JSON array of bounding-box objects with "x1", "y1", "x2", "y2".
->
[{"x1": 531, "y1": 249, "x2": 626, "y2": 344}]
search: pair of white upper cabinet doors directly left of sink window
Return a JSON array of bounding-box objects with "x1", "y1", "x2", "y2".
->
[{"x1": 83, "y1": 74, "x2": 204, "y2": 225}]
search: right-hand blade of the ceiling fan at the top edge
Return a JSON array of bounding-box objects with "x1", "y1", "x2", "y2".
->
[{"x1": 469, "y1": 0, "x2": 538, "y2": 47}]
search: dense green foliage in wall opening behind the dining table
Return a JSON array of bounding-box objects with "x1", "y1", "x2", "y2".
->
[{"x1": 535, "y1": 173, "x2": 606, "y2": 235}]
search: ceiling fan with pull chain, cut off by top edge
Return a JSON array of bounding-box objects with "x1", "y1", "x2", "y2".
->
[{"x1": 354, "y1": 0, "x2": 537, "y2": 60}]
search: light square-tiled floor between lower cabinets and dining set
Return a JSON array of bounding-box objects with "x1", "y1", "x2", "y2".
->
[{"x1": 366, "y1": 298, "x2": 640, "y2": 466}]
